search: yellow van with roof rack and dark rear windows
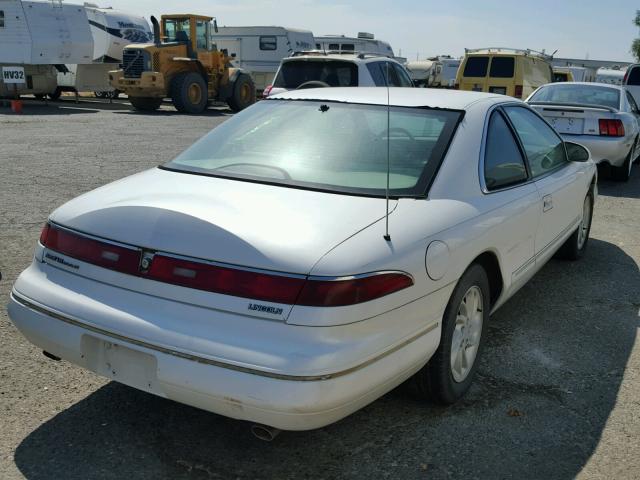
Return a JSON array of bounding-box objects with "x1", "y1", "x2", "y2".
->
[{"x1": 456, "y1": 48, "x2": 553, "y2": 99}]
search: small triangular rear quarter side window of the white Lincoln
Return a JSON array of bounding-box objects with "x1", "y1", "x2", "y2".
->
[{"x1": 484, "y1": 112, "x2": 527, "y2": 190}]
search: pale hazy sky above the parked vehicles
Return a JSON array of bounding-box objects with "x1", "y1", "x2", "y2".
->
[{"x1": 105, "y1": 0, "x2": 640, "y2": 62}]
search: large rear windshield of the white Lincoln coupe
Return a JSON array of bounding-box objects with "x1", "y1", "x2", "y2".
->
[{"x1": 165, "y1": 100, "x2": 461, "y2": 197}]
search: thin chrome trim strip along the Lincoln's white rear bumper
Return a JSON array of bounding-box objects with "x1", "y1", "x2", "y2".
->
[{"x1": 11, "y1": 291, "x2": 440, "y2": 382}]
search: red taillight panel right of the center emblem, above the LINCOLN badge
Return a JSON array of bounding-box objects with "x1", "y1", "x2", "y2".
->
[{"x1": 146, "y1": 255, "x2": 305, "y2": 304}]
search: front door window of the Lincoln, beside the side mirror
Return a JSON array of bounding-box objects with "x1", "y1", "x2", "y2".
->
[{"x1": 505, "y1": 107, "x2": 568, "y2": 178}]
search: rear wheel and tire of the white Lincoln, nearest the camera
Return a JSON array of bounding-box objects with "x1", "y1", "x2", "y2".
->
[{"x1": 408, "y1": 264, "x2": 491, "y2": 405}]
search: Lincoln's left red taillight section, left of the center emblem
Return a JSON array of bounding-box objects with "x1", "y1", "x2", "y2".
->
[{"x1": 40, "y1": 224, "x2": 140, "y2": 275}]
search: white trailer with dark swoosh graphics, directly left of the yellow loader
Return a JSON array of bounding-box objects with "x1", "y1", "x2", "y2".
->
[{"x1": 57, "y1": 5, "x2": 153, "y2": 97}]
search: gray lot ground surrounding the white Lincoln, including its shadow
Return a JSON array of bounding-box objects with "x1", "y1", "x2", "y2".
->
[{"x1": 0, "y1": 97, "x2": 640, "y2": 480}]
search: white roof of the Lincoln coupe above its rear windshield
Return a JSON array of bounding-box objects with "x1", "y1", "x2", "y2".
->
[{"x1": 267, "y1": 87, "x2": 520, "y2": 110}]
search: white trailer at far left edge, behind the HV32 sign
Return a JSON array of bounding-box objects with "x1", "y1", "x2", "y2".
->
[{"x1": 0, "y1": 0, "x2": 93, "y2": 96}]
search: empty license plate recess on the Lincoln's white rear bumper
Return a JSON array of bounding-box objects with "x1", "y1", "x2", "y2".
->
[{"x1": 82, "y1": 335, "x2": 163, "y2": 395}]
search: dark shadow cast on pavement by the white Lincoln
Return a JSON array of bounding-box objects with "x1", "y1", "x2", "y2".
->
[{"x1": 15, "y1": 239, "x2": 640, "y2": 480}]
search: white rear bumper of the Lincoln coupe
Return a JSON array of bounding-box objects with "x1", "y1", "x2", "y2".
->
[{"x1": 8, "y1": 267, "x2": 440, "y2": 430}]
